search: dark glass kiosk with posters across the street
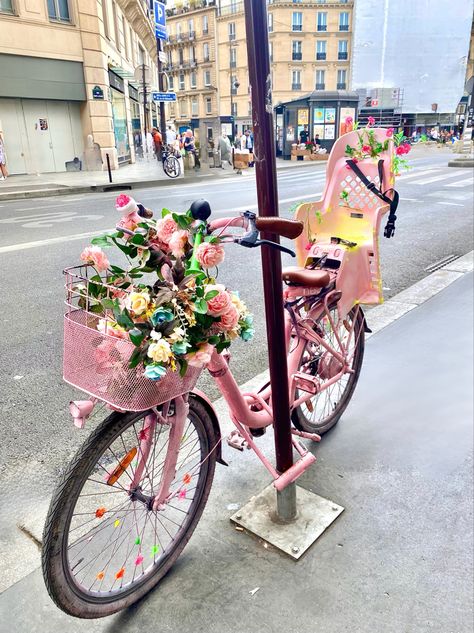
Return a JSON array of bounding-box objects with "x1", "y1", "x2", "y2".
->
[{"x1": 275, "y1": 90, "x2": 359, "y2": 159}]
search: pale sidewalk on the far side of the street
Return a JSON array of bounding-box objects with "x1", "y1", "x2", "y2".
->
[{"x1": 0, "y1": 159, "x2": 326, "y2": 202}]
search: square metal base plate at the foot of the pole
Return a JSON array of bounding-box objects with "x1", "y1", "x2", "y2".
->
[{"x1": 230, "y1": 484, "x2": 344, "y2": 560}]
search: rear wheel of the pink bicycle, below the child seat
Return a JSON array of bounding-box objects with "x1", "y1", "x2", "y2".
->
[{"x1": 291, "y1": 306, "x2": 365, "y2": 435}]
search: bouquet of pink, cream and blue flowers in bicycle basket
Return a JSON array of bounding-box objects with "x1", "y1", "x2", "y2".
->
[{"x1": 74, "y1": 194, "x2": 253, "y2": 381}]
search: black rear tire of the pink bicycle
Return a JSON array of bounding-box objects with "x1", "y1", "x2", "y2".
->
[{"x1": 291, "y1": 308, "x2": 365, "y2": 435}]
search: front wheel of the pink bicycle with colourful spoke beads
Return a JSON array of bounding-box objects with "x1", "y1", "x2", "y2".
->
[{"x1": 42, "y1": 398, "x2": 216, "y2": 618}]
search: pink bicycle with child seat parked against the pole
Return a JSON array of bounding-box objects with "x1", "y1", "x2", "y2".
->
[{"x1": 43, "y1": 130, "x2": 395, "y2": 618}]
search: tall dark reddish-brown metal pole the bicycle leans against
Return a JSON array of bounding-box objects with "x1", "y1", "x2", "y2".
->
[{"x1": 244, "y1": 0, "x2": 296, "y2": 521}]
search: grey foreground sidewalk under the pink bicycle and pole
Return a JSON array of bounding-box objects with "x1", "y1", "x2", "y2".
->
[{"x1": 0, "y1": 254, "x2": 473, "y2": 633}]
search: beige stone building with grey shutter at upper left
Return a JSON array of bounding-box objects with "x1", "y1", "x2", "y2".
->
[{"x1": 0, "y1": 0, "x2": 157, "y2": 174}]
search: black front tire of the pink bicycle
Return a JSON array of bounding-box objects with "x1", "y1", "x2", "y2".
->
[{"x1": 42, "y1": 398, "x2": 216, "y2": 619}]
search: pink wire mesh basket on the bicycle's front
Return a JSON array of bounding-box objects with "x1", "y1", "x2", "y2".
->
[{"x1": 63, "y1": 266, "x2": 202, "y2": 411}]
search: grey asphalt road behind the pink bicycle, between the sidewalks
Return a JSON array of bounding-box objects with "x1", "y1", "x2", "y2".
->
[{"x1": 0, "y1": 148, "x2": 473, "y2": 591}]
